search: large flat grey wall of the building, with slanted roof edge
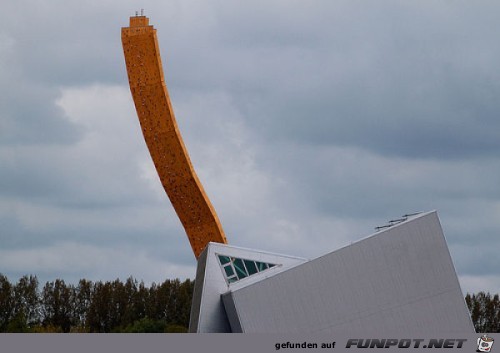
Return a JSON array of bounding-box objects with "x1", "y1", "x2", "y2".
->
[{"x1": 223, "y1": 212, "x2": 474, "y2": 334}]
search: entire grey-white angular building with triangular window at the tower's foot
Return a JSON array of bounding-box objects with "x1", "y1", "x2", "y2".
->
[{"x1": 189, "y1": 211, "x2": 474, "y2": 334}]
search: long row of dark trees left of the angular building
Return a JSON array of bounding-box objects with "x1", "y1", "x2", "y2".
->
[{"x1": 0, "y1": 274, "x2": 194, "y2": 333}]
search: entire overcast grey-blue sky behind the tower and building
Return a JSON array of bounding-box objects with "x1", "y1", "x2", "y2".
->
[{"x1": 0, "y1": 0, "x2": 500, "y2": 293}]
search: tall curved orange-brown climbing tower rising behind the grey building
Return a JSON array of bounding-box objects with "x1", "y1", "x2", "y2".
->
[{"x1": 122, "y1": 16, "x2": 227, "y2": 258}]
